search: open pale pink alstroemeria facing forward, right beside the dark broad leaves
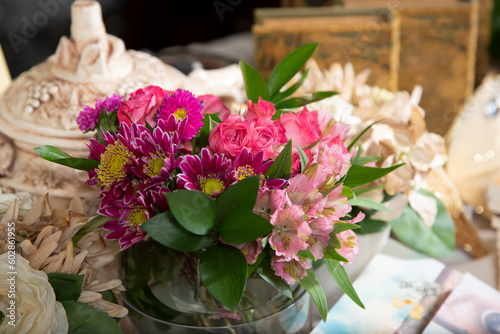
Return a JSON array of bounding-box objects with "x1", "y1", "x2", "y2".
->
[{"x1": 269, "y1": 205, "x2": 312, "y2": 259}]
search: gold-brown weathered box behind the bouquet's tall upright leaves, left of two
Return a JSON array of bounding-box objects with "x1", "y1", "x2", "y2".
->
[{"x1": 253, "y1": 7, "x2": 399, "y2": 91}]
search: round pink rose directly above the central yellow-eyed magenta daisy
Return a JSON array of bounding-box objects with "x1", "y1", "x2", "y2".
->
[{"x1": 208, "y1": 115, "x2": 257, "y2": 157}]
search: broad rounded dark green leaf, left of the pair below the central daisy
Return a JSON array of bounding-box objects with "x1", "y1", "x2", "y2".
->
[{"x1": 165, "y1": 190, "x2": 217, "y2": 235}]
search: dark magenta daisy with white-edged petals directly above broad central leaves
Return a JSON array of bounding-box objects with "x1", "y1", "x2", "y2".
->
[{"x1": 177, "y1": 148, "x2": 236, "y2": 198}]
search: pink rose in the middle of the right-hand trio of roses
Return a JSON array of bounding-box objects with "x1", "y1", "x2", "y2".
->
[{"x1": 251, "y1": 117, "x2": 287, "y2": 160}]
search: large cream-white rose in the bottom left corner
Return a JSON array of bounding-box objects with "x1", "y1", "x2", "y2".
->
[{"x1": 0, "y1": 253, "x2": 68, "y2": 334}]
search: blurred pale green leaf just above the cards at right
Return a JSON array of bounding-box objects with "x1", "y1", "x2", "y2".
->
[{"x1": 390, "y1": 196, "x2": 455, "y2": 257}]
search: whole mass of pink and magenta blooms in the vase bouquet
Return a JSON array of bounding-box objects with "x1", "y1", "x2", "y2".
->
[{"x1": 77, "y1": 86, "x2": 364, "y2": 284}]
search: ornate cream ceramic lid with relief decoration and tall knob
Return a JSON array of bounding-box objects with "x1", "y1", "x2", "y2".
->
[{"x1": 0, "y1": 0, "x2": 186, "y2": 211}]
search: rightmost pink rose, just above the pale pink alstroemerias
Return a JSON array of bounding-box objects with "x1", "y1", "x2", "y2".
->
[{"x1": 279, "y1": 107, "x2": 322, "y2": 148}]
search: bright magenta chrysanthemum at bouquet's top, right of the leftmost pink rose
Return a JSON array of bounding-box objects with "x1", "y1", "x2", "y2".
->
[{"x1": 157, "y1": 89, "x2": 203, "y2": 140}]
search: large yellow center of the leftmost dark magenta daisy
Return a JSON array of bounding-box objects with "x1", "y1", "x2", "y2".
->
[{"x1": 97, "y1": 141, "x2": 134, "y2": 187}]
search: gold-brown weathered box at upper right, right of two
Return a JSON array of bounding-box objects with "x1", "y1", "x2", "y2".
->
[{"x1": 345, "y1": 0, "x2": 478, "y2": 135}]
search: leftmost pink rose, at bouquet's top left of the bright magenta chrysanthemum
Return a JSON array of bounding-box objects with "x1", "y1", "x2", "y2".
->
[{"x1": 118, "y1": 86, "x2": 170, "y2": 127}]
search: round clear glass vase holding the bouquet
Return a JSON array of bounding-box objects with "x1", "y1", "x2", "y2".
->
[{"x1": 121, "y1": 240, "x2": 311, "y2": 334}]
